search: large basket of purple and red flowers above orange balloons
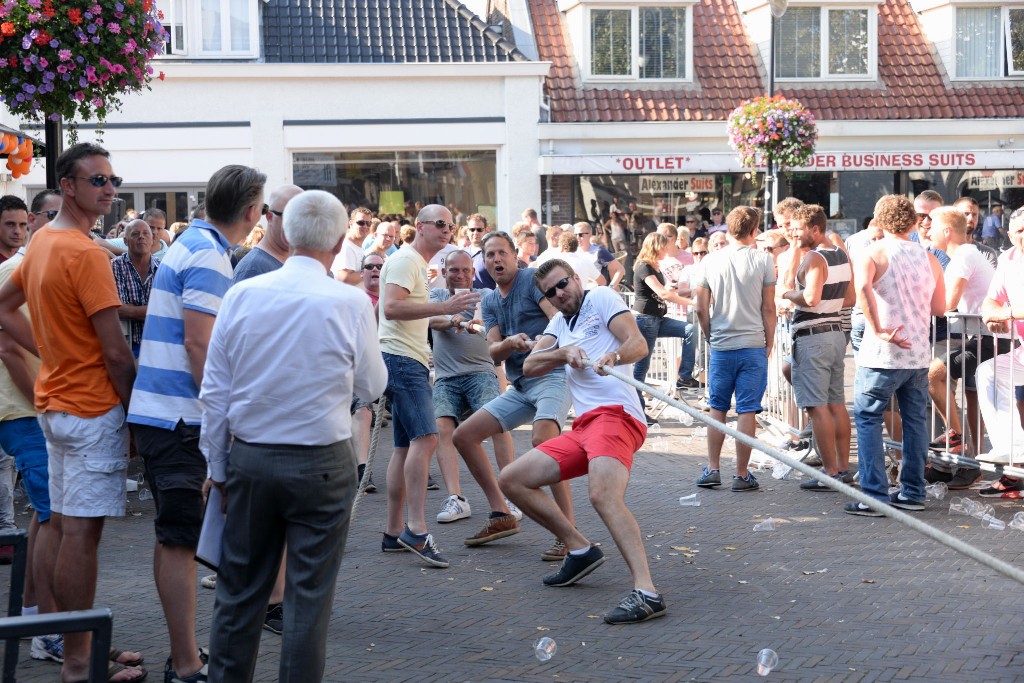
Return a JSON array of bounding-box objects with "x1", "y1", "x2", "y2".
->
[{"x1": 0, "y1": 0, "x2": 166, "y2": 130}]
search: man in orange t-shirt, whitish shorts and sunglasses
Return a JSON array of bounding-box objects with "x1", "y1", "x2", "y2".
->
[{"x1": 0, "y1": 142, "x2": 145, "y2": 681}]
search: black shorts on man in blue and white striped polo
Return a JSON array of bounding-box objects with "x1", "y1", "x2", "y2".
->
[{"x1": 132, "y1": 420, "x2": 207, "y2": 548}]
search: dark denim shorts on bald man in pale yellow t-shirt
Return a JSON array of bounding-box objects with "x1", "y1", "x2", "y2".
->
[{"x1": 382, "y1": 353, "x2": 437, "y2": 449}]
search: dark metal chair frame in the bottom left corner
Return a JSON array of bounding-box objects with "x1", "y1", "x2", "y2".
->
[{"x1": 0, "y1": 529, "x2": 114, "y2": 683}]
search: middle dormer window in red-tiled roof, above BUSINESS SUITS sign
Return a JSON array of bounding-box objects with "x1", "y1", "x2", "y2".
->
[{"x1": 774, "y1": 7, "x2": 878, "y2": 80}]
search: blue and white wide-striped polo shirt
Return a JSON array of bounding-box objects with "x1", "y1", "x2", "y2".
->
[{"x1": 128, "y1": 219, "x2": 231, "y2": 429}]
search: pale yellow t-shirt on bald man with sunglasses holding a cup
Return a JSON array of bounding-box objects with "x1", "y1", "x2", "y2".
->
[{"x1": 378, "y1": 247, "x2": 430, "y2": 368}]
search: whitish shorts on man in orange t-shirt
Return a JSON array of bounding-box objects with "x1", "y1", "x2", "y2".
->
[{"x1": 39, "y1": 403, "x2": 128, "y2": 517}]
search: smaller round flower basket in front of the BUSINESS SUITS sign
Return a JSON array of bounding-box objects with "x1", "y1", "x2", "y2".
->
[{"x1": 726, "y1": 95, "x2": 818, "y2": 169}]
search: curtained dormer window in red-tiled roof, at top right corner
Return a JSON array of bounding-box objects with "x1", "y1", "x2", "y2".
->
[{"x1": 953, "y1": 5, "x2": 1024, "y2": 79}]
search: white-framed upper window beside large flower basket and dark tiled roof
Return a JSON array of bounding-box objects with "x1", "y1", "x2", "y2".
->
[{"x1": 160, "y1": 0, "x2": 259, "y2": 58}]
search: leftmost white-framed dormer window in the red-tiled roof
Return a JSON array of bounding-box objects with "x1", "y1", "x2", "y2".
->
[{"x1": 588, "y1": 6, "x2": 692, "y2": 81}]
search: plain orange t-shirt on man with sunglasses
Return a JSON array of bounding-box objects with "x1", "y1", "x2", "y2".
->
[{"x1": 11, "y1": 226, "x2": 121, "y2": 418}]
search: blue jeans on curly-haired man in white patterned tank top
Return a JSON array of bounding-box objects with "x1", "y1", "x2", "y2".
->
[{"x1": 853, "y1": 367, "x2": 929, "y2": 503}]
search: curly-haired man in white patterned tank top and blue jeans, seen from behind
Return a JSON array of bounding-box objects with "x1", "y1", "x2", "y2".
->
[{"x1": 844, "y1": 195, "x2": 945, "y2": 517}]
